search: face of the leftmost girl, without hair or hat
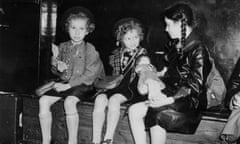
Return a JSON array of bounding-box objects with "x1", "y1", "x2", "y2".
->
[{"x1": 68, "y1": 18, "x2": 88, "y2": 43}]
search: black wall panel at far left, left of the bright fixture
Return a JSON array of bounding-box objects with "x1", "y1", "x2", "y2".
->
[{"x1": 0, "y1": 0, "x2": 40, "y2": 93}]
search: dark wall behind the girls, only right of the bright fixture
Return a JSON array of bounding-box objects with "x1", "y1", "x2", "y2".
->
[{"x1": 53, "y1": 0, "x2": 240, "y2": 81}]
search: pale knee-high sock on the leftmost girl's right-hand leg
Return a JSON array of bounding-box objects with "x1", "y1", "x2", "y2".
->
[{"x1": 66, "y1": 113, "x2": 79, "y2": 144}]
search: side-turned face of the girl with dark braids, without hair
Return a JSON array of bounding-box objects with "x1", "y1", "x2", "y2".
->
[{"x1": 164, "y1": 18, "x2": 181, "y2": 39}]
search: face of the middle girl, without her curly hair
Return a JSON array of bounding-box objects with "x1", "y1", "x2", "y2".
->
[{"x1": 123, "y1": 29, "x2": 140, "y2": 49}]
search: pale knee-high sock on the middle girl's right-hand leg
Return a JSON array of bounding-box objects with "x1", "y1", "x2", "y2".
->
[{"x1": 104, "y1": 108, "x2": 120, "y2": 140}]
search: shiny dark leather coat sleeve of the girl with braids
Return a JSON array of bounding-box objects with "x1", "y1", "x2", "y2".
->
[{"x1": 174, "y1": 45, "x2": 210, "y2": 99}]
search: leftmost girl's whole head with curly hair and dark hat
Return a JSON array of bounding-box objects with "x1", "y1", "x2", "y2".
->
[{"x1": 63, "y1": 7, "x2": 95, "y2": 42}]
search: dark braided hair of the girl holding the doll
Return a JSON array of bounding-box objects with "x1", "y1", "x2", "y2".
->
[{"x1": 163, "y1": 3, "x2": 196, "y2": 46}]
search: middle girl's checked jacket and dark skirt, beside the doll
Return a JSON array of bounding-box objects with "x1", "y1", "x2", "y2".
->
[{"x1": 104, "y1": 48, "x2": 146, "y2": 103}]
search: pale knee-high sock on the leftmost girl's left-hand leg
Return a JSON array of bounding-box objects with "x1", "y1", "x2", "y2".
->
[{"x1": 39, "y1": 113, "x2": 52, "y2": 144}]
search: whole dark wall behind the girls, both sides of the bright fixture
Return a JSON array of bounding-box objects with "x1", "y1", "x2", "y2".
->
[{"x1": 0, "y1": 0, "x2": 240, "y2": 91}]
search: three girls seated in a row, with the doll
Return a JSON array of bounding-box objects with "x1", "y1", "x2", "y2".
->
[{"x1": 39, "y1": 3, "x2": 231, "y2": 144}]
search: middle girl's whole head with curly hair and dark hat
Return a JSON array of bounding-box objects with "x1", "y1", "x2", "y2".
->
[{"x1": 114, "y1": 18, "x2": 144, "y2": 49}]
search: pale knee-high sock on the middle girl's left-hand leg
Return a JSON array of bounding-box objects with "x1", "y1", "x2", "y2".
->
[{"x1": 92, "y1": 111, "x2": 105, "y2": 143}]
